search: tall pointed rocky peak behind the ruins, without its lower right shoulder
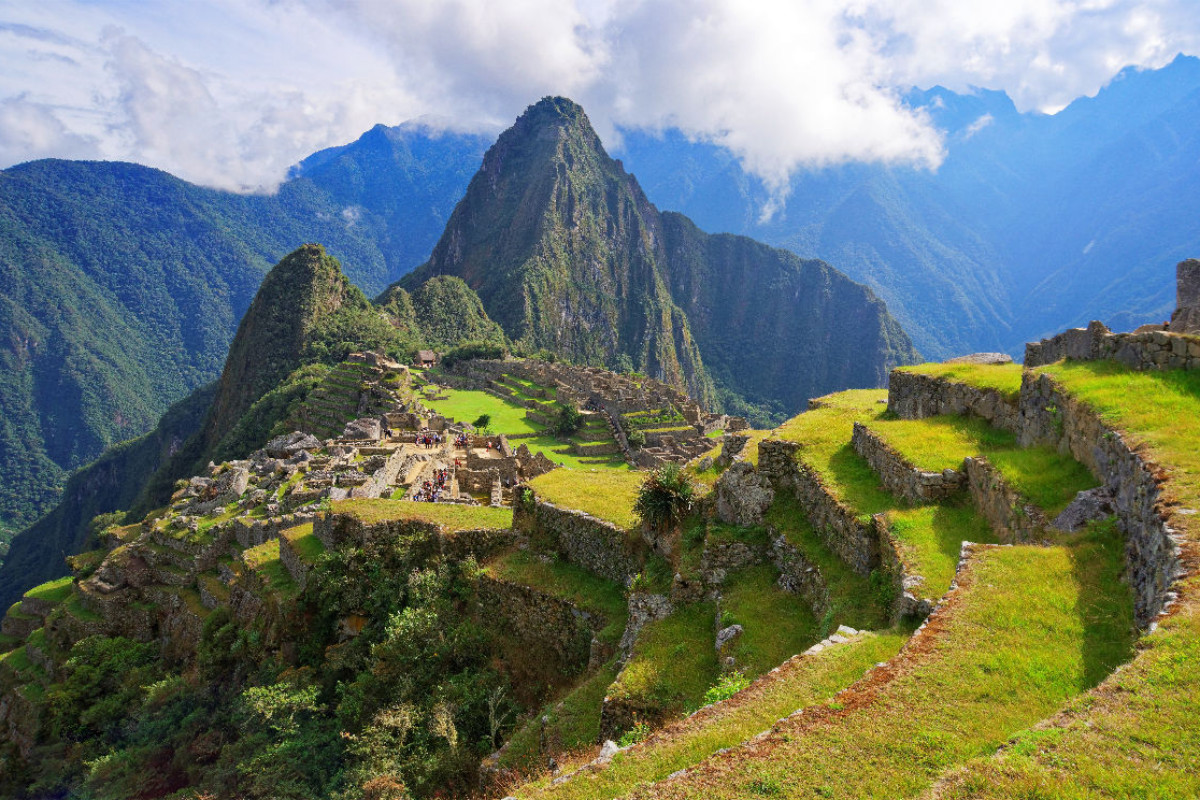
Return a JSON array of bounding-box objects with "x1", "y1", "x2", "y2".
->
[{"x1": 402, "y1": 98, "x2": 713, "y2": 403}]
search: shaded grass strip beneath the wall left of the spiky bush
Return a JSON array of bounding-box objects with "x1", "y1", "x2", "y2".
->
[{"x1": 487, "y1": 551, "x2": 628, "y2": 643}]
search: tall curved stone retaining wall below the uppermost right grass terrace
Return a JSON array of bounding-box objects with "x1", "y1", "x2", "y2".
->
[{"x1": 1020, "y1": 372, "x2": 1182, "y2": 627}]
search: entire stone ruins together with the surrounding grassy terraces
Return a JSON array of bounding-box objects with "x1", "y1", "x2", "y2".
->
[{"x1": 0, "y1": 257, "x2": 1200, "y2": 799}]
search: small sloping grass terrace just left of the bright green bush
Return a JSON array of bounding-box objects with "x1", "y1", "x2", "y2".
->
[{"x1": 608, "y1": 602, "x2": 720, "y2": 716}]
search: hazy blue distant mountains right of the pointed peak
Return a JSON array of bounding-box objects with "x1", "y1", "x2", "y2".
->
[{"x1": 620, "y1": 56, "x2": 1200, "y2": 357}]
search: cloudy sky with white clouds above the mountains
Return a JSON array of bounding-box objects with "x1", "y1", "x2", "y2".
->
[{"x1": 0, "y1": 0, "x2": 1200, "y2": 191}]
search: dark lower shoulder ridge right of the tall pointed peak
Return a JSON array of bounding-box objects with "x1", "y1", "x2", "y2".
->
[{"x1": 661, "y1": 212, "x2": 917, "y2": 410}]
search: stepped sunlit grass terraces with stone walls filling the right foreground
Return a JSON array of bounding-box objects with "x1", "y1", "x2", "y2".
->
[{"x1": 494, "y1": 350, "x2": 1200, "y2": 798}]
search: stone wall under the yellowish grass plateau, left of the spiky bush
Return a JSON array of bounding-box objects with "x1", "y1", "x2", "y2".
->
[{"x1": 512, "y1": 489, "x2": 643, "y2": 585}]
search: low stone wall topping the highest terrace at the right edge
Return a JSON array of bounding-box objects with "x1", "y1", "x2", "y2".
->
[{"x1": 1025, "y1": 321, "x2": 1200, "y2": 369}]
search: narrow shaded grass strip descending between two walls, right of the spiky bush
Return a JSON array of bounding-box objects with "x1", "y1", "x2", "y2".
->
[{"x1": 766, "y1": 492, "x2": 890, "y2": 633}]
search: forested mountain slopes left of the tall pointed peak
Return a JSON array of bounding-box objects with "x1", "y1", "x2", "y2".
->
[{"x1": 0, "y1": 126, "x2": 488, "y2": 539}]
